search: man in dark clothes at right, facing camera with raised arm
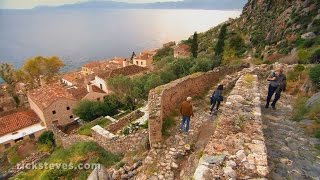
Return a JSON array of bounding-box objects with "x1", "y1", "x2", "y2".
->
[{"x1": 265, "y1": 68, "x2": 287, "y2": 109}]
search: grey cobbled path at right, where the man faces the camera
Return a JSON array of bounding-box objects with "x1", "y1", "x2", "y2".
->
[{"x1": 260, "y1": 79, "x2": 320, "y2": 180}]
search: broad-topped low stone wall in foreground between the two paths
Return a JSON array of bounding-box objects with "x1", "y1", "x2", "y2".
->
[{"x1": 194, "y1": 75, "x2": 268, "y2": 179}]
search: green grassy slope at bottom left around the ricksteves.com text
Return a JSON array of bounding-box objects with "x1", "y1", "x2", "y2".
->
[{"x1": 11, "y1": 142, "x2": 122, "y2": 179}]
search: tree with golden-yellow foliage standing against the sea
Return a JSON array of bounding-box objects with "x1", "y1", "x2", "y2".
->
[{"x1": 17, "y1": 56, "x2": 64, "y2": 87}]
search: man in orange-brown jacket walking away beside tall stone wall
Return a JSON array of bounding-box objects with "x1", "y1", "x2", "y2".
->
[{"x1": 180, "y1": 97, "x2": 194, "y2": 132}]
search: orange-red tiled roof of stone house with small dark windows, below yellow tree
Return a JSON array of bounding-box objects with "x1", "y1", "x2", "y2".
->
[{"x1": 28, "y1": 84, "x2": 75, "y2": 110}]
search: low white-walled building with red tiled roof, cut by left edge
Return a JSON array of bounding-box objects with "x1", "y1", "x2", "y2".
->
[{"x1": 0, "y1": 110, "x2": 46, "y2": 152}]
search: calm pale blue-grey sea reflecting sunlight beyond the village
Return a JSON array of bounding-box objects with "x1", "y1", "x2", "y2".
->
[{"x1": 0, "y1": 10, "x2": 241, "y2": 73}]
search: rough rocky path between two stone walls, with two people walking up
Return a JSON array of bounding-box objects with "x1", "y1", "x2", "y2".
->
[{"x1": 136, "y1": 68, "x2": 248, "y2": 180}]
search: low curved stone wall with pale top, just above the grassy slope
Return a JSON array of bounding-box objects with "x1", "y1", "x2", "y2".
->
[{"x1": 91, "y1": 125, "x2": 148, "y2": 153}]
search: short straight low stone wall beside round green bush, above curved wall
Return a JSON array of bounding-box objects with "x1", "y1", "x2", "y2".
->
[{"x1": 106, "y1": 110, "x2": 144, "y2": 134}]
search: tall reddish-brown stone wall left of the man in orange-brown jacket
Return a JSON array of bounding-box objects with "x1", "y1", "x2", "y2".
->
[{"x1": 148, "y1": 67, "x2": 242, "y2": 146}]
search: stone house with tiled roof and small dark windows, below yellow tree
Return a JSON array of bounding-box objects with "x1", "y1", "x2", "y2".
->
[{"x1": 28, "y1": 84, "x2": 77, "y2": 128}]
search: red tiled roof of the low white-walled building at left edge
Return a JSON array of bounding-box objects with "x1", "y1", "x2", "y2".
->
[{"x1": 0, "y1": 110, "x2": 40, "y2": 136}]
